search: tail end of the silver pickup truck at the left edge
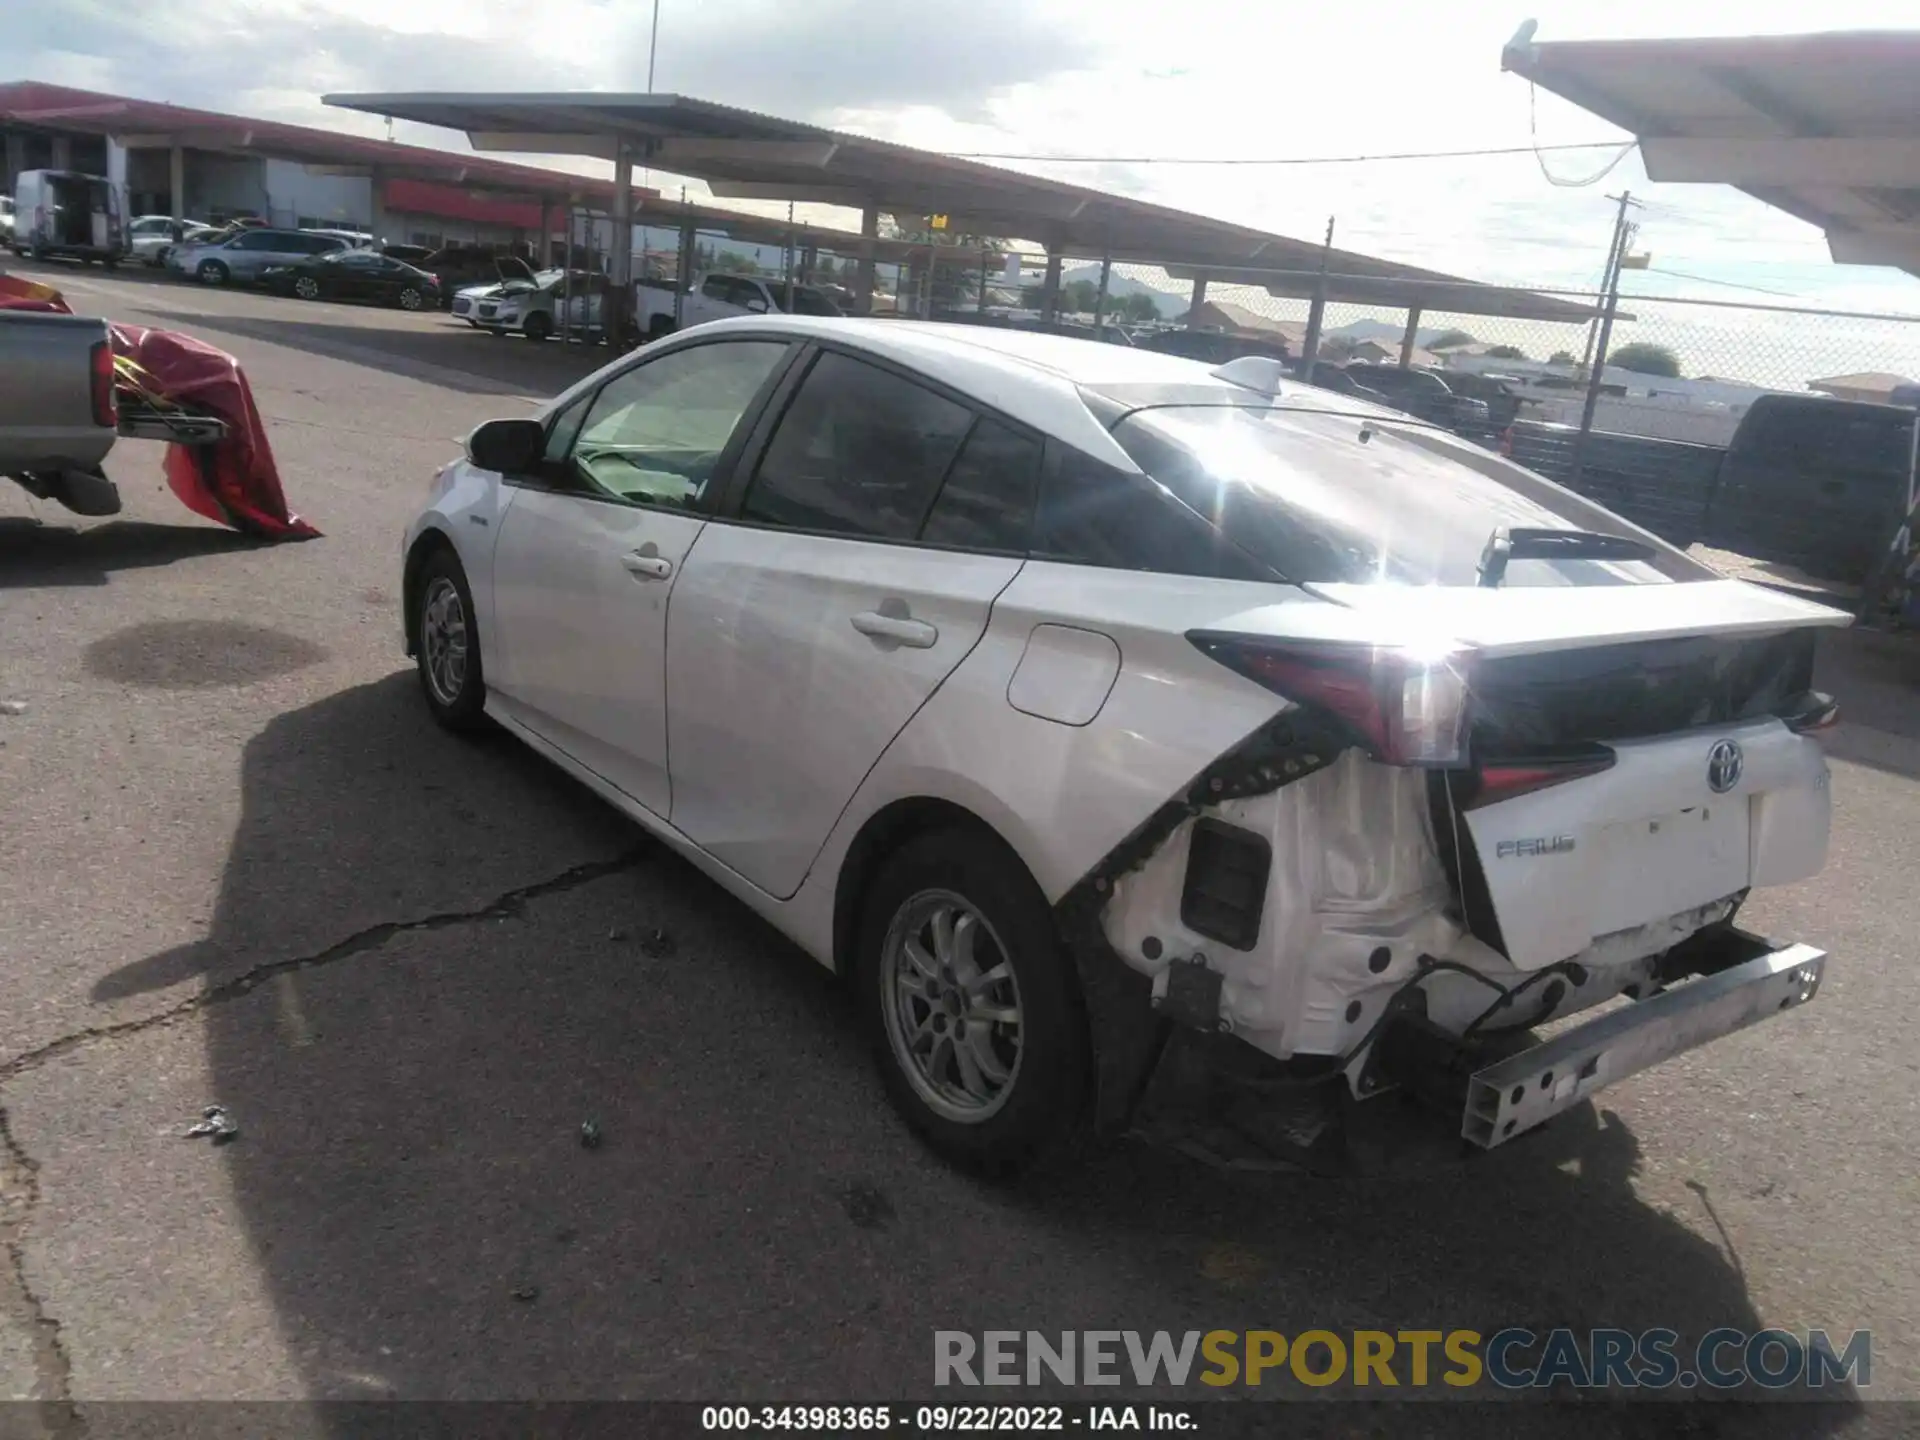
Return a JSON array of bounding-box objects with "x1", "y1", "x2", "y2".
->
[{"x1": 0, "y1": 311, "x2": 227, "y2": 515}]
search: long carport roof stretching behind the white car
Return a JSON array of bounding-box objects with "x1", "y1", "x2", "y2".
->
[{"x1": 323, "y1": 92, "x2": 1592, "y2": 321}]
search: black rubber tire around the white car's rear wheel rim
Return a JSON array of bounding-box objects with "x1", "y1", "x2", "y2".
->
[{"x1": 852, "y1": 829, "x2": 1089, "y2": 1175}]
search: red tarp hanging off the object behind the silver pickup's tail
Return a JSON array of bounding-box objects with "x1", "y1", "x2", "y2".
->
[{"x1": 0, "y1": 275, "x2": 321, "y2": 540}]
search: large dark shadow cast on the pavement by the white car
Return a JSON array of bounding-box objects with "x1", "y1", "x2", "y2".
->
[{"x1": 86, "y1": 676, "x2": 1851, "y2": 1436}]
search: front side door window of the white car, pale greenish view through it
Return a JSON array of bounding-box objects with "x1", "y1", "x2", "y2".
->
[{"x1": 549, "y1": 340, "x2": 787, "y2": 509}]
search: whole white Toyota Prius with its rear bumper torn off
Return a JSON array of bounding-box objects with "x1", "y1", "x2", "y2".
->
[{"x1": 403, "y1": 317, "x2": 1847, "y2": 1167}]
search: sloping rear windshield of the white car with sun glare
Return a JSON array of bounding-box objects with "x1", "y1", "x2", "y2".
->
[{"x1": 1114, "y1": 405, "x2": 1703, "y2": 589}]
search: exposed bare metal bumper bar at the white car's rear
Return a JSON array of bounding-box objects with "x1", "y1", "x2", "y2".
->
[{"x1": 1459, "y1": 927, "x2": 1826, "y2": 1150}]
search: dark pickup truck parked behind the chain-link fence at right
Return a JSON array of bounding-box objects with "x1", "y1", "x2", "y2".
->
[{"x1": 1501, "y1": 394, "x2": 1920, "y2": 584}]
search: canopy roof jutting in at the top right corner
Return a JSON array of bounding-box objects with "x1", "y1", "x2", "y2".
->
[{"x1": 1501, "y1": 21, "x2": 1920, "y2": 275}]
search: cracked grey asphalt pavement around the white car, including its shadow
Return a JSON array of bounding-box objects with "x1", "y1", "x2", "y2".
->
[{"x1": 0, "y1": 265, "x2": 1920, "y2": 1434}]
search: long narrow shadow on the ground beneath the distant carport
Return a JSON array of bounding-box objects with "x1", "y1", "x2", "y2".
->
[{"x1": 142, "y1": 300, "x2": 611, "y2": 397}]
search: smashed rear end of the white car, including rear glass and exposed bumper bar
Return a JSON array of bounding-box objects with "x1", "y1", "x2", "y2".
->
[{"x1": 1058, "y1": 397, "x2": 1847, "y2": 1165}]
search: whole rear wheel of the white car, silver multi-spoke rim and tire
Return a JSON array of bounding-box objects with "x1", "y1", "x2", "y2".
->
[{"x1": 854, "y1": 829, "x2": 1089, "y2": 1173}]
